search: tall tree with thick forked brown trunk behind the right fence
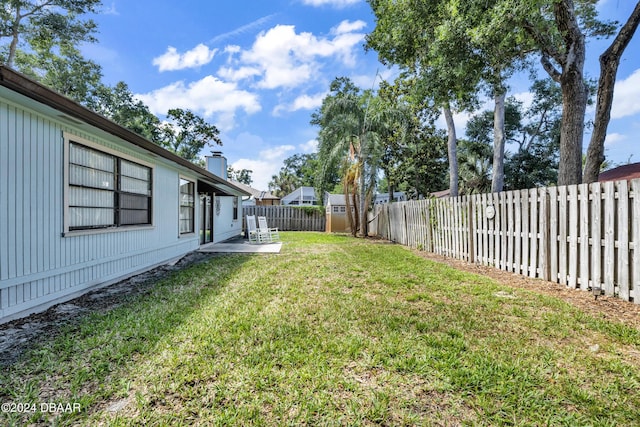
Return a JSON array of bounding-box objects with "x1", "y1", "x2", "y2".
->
[{"x1": 487, "y1": 0, "x2": 615, "y2": 185}]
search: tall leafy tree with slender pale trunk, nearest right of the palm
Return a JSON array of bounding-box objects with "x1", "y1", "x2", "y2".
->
[{"x1": 367, "y1": 0, "x2": 490, "y2": 196}]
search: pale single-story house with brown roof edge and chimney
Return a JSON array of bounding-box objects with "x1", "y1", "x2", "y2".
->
[{"x1": 0, "y1": 66, "x2": 248, "y2": 323}]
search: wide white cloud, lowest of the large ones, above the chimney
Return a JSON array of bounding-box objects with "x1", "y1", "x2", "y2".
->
[{"x1": 137, "y1": 76, "x2": 261, "y2": 131}]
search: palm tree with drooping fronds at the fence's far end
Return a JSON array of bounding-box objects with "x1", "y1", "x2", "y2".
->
[{"x1": 312, "y1": 81, "x2": 405, "y2": 236}]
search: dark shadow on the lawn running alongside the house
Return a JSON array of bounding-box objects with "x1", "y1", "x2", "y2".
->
[{"x1": 0, "y1": 252, "x2": 255, "y2": 425}]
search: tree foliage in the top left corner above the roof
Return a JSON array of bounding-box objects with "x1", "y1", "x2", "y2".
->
[{"x1": 0, "y1": 0, "x2": 101, "y2": 67}]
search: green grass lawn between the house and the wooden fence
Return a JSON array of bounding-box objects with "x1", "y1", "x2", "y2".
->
[{"x1": 0, "y1": 233, "x2": 640, "y2": 426}]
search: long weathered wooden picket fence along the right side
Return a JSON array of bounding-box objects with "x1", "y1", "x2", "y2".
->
[{"x1": 370, "y1": 179, "x2": 640, "y2": 303}]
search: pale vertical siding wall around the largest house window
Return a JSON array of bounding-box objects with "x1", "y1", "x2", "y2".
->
[{"x1": 0, "y1": 99, "x2": 198, "y2": 323}]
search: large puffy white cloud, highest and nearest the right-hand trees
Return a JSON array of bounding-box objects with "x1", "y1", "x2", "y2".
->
[{"x1": 219, "y1": 21, "x2": 365, "y2": 89}]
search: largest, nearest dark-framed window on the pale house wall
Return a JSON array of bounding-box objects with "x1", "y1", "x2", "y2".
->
[{"x1": 68, "y1": 142, "x2": 151, "y2": 230}]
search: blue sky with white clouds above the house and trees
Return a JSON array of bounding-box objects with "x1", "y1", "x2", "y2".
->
[{"x1": 83, "y1": 0, "x2": 640, "y2": 189}]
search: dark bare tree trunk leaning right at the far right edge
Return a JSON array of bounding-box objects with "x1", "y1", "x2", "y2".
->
[{"x1": 583, "y1": 2, "x2": 640, "y2": 183}]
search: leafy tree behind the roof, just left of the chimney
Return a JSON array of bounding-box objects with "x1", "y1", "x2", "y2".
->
[{"x1": 160, "y1": 108, "x2": 222, "y2": 163}]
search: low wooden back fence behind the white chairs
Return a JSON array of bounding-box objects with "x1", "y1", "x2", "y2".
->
[{"x1": 242, "y1": 205, "x2": 326, "y2": 231}]
